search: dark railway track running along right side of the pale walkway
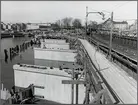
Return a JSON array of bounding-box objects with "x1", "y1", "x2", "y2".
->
[{"x1": 63, "y1": 36, "x2": 137, "y2": 76}]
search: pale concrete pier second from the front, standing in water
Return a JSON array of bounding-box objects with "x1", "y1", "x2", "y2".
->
[{"x1": 34, "y1": 48, "x2": 77, "y2": 62}]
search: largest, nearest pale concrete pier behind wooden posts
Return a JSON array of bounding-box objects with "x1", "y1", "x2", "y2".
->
[{"x1": 13, "y1": 65, "x2": 85, "y2": 104}]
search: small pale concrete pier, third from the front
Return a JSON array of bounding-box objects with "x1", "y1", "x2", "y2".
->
[{"x1": 41, "y1": 42, "x2": 69, "y2": 50}]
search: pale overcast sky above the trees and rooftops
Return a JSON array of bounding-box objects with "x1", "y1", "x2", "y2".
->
[{"x1": 1, "y1": 1, "x2": 137, "y2": 23}]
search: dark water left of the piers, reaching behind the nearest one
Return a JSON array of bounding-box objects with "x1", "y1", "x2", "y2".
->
[{"x1": 1, "y1": 37, "x2": 74, "y2": 89}]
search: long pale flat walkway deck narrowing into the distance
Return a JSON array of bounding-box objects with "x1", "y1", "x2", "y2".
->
[{"x1": 79, "y1": 39, "x2": 137, "y2": 104}]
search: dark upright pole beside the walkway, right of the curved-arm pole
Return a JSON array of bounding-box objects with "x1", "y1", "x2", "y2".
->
[{"x1": 109, "y1": 12, "x2": 113, "y2": 60}]
